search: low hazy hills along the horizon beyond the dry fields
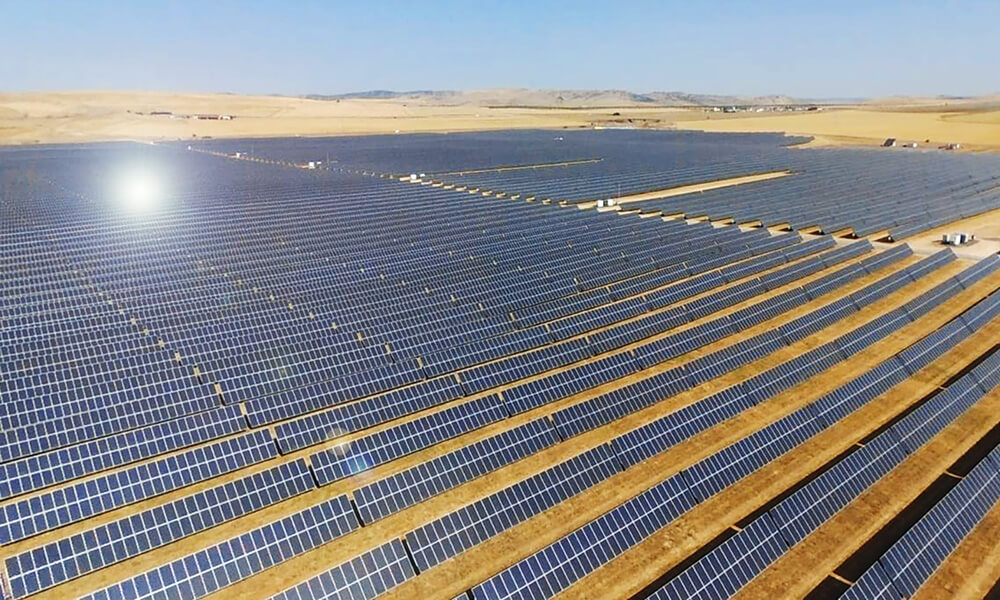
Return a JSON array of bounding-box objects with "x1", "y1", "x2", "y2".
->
[{"x1": 307, "y1": 88, "x2": 817, "y2": 108}]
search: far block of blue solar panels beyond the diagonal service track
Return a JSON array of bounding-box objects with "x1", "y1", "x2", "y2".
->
[{"x1": 193, "y1": 131, "x2": 1000, "y2": 240}]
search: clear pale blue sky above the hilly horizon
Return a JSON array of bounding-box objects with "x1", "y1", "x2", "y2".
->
[{"x1": 0, "y1": 0, "x2": 1000, "y2": 97}]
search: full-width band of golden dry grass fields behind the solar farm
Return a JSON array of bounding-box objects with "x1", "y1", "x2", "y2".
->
[{"x1": 0, "y1": 92, "x2": 1000, "y2": 150}]
